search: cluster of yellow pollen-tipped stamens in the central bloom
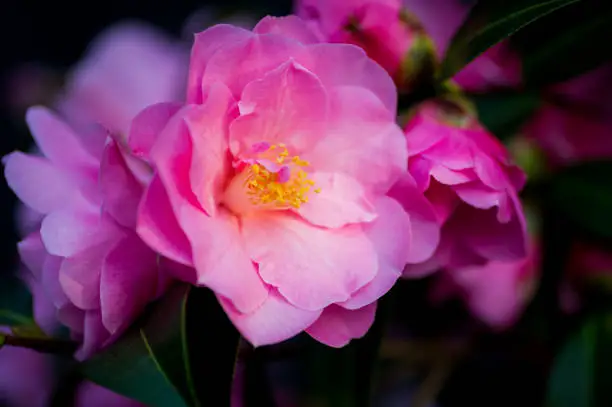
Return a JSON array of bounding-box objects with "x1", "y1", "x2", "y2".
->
[{"x1": 245, "y1": 144, "x2": 321, "y2": 209}]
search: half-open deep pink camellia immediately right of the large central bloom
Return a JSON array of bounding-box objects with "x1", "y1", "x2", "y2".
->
[{"x1": 392, "y1": 101, "x2": 527, "y2": 273}]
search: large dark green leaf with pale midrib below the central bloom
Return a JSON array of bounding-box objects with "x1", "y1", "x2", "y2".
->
[{"x1": 82, "y1": 285, "x2": 239, "y2": 407}]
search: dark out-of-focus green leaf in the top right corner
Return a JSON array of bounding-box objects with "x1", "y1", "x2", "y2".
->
[{"x1": 517, "y1": 2, "x2": 612, "y2": 87}]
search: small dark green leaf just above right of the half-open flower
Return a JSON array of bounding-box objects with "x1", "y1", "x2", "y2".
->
[{"x1": 471, "y1": 92, "x2": 541, "y2": 140}]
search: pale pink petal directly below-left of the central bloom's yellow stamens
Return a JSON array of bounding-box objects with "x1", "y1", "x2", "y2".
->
[{"x1": 179, "y1": 206, "x2": 268, "y2": 312}]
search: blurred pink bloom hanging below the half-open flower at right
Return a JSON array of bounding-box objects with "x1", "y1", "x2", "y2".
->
[{"x1": 432, "y1": 241, "x2": 539, "y2": 329}]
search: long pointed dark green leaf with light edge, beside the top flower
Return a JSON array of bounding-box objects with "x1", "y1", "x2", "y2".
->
[{"x1": 440, "y1": 0, "x2": 580, "y2": 80}]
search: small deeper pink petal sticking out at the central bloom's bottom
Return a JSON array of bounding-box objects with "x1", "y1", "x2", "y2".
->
[{"x1": 306, "y1": 303, "x2": 376, "y2": 348}]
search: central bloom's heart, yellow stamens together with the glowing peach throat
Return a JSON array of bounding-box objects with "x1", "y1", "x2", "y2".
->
[{"x1": 224, "y1": 142, "x2": 320, "y2": 213}]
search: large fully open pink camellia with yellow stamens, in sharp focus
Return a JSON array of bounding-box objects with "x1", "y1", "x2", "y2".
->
[{"x1": 129, "y1": 16, "x2": 438, "y2": 346}]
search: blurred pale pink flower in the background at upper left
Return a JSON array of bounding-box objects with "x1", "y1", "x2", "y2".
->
[{"x1": 60, "y1": 23, "x2": 187, "y2": 137}]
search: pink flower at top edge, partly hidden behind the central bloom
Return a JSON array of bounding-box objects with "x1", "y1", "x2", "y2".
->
[{"x1": 295, "y1": 0, "x2": 435, "y2": 87}]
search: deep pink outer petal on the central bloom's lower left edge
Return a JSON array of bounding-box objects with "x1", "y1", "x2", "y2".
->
[{"x1": 137, "y1": 176, "x2": 193, "y2": 265}]
